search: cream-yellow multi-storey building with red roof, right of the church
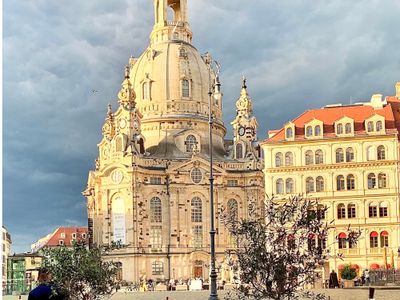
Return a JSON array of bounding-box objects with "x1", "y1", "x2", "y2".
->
[{"x1": 261, "y1": 82, "x2": 400, "y2": 274}]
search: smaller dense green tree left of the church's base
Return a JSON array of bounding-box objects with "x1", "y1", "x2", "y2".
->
[{"x1": 43, "y1": 242, "x2": 117, "y2": 300}]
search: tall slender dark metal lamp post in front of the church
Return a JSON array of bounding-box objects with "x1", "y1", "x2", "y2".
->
[{"x1": 208, "y1": 59, "x2": 218, "y2": 300}]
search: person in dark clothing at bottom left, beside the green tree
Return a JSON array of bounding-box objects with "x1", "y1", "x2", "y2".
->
[{"x1": 28, "y1": 268, "x2": 66, "y2": 300}]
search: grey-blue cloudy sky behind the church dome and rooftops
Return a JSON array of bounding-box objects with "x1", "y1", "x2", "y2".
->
[{"x1": 3, "y1": 0, "x2": 400, "y2": 253}]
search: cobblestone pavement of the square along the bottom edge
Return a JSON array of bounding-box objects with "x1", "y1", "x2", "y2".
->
[{"x1": 3, "y1": 289, "x2": 400, "y2": 300}]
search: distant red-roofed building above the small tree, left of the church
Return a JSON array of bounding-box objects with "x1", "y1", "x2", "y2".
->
[{"x1": 31, "y1": 227, "x2": 88, "y2": 253}]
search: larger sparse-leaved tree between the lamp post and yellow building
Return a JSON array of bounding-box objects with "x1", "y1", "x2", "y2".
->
[{"x1": 222, "y1": 196, "x2": 360, "y2": 300}]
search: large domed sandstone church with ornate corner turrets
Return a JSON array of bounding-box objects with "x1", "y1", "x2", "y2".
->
[{"x1": 83, "y1": 0, "x2": 265, "y2": 282}]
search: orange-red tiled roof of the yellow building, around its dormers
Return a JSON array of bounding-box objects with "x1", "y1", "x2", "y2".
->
[{"x1": 264, "y1": 97, "x2": 400, "y2": 143}]
